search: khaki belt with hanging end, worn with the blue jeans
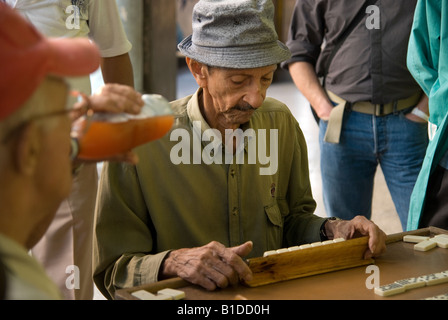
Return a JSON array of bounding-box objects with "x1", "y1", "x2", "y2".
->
[{"x1": 324, "y1": 91, "x2": 422, "y2": 143}]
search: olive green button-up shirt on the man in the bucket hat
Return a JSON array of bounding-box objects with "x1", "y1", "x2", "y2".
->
[{"x1": 94, "y1": 91, "x2": 324, "y2": 296}]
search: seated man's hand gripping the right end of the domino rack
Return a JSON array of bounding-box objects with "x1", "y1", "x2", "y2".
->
[{"x1": 325, "y1": 216, "x2": 386, "y2": 259}]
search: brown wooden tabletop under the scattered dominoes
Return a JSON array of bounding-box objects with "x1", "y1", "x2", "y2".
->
[{"x1": 115, "y1": 227, "x2": 448, "y2": 300}]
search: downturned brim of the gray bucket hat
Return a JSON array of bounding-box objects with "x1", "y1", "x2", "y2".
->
[{"x1": 178, "y1": 35, "x2": 291, "y2": 69}]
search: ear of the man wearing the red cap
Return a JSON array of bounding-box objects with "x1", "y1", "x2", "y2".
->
[{"x1": 13, "y1": 121, "x2": 42, "y2": 176}]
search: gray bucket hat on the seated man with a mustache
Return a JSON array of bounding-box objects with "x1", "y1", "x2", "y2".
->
[{"x1": 178, "y1": 0, "x2": 291, "y2": 69}]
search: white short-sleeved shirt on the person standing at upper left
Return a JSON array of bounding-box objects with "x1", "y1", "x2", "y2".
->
[{"x1": 6, "y1": 0, "x2": 132, "y2": 94}]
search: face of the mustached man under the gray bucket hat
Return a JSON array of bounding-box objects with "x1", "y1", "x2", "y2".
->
[{"x1": 204, "y1": 65, "x2": 277, "y2": 128}]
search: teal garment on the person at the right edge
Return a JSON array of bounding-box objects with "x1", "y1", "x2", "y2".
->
[{"x1": 407, "y1": 0, "x2": 448, "y2": 230}]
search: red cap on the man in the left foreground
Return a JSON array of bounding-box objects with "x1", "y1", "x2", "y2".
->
[{"x1": 0, "y1": 2, "x2": 101, "y2": 120}]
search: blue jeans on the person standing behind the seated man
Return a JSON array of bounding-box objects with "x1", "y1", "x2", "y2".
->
[{"x1": 319, "y1": 110, "x2": 428, "y2": 230}]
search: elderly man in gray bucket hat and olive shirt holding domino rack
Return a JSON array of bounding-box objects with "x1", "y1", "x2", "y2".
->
[{"x1": 94, "y1": 0, "x2": 385, "y2": 298}]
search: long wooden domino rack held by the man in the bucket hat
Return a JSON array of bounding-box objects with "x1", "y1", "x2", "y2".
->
[{"x1": 245, "y1": 237, "x2": 374, "y2": 287}]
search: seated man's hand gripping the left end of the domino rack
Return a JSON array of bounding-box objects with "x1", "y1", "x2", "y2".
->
[{"x1": 161, "y1": 241, "x2": 253, "y2": 290}]
